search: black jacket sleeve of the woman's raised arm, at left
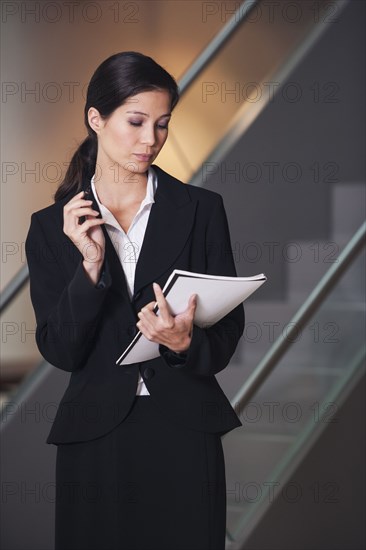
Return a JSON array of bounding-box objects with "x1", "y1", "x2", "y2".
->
[{"x1": 25, "y1": 214, "x2": 111, "y2": 371}]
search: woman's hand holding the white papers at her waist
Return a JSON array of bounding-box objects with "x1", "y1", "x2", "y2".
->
[{"x1": 137, "y1": 283, "x2": 197, "y2": 353}]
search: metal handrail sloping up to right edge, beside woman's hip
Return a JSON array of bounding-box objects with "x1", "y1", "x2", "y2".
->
[{"x1": 231, "y1": 221, "x2": 366, "y2": 410}]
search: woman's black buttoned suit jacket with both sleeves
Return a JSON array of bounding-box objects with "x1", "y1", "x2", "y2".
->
[{"x1": 26, "y1": 166, "x2": 244, "y2": 444}]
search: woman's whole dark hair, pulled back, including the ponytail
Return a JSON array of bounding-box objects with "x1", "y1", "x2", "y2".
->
[{"x1": 55, "y1": 52, "x2": 179, "y2": 201}]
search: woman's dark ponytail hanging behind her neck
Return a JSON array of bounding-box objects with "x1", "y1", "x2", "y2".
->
[{"x1": 55, "y1": 132, "x2": 98, "y2": 202}]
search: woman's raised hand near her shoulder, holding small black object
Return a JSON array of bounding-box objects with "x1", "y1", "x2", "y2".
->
[{"x1": 63, "y1": 191, "x2": 105, "y2": 284}]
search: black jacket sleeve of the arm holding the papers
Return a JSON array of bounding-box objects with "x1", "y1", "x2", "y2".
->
[{"x1": 160, "y1": 196, "x2": 244, "y2": 376}]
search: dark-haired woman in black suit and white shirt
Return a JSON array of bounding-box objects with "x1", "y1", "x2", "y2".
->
[{"x1": 26, "y1": 52, "x2": 244, "y2": 550}]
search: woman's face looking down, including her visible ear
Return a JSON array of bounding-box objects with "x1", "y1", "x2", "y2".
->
[{"x1": 88, "y1": 90, "x2": 171, "y2": 176}]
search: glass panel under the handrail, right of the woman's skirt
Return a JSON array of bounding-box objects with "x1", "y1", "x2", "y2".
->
[{"x1": 224, "y1": 246, "x2": 366, "y2": 539}]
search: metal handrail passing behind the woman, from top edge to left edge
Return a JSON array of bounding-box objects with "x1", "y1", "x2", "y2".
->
[{"x1": 0, "y1": 0, "x2": 258, "y2": 313}]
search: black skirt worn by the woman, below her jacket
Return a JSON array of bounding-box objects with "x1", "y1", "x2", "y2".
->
[{"x1": 56, "y1": 396, "x2": 226, "y2": 550}]
